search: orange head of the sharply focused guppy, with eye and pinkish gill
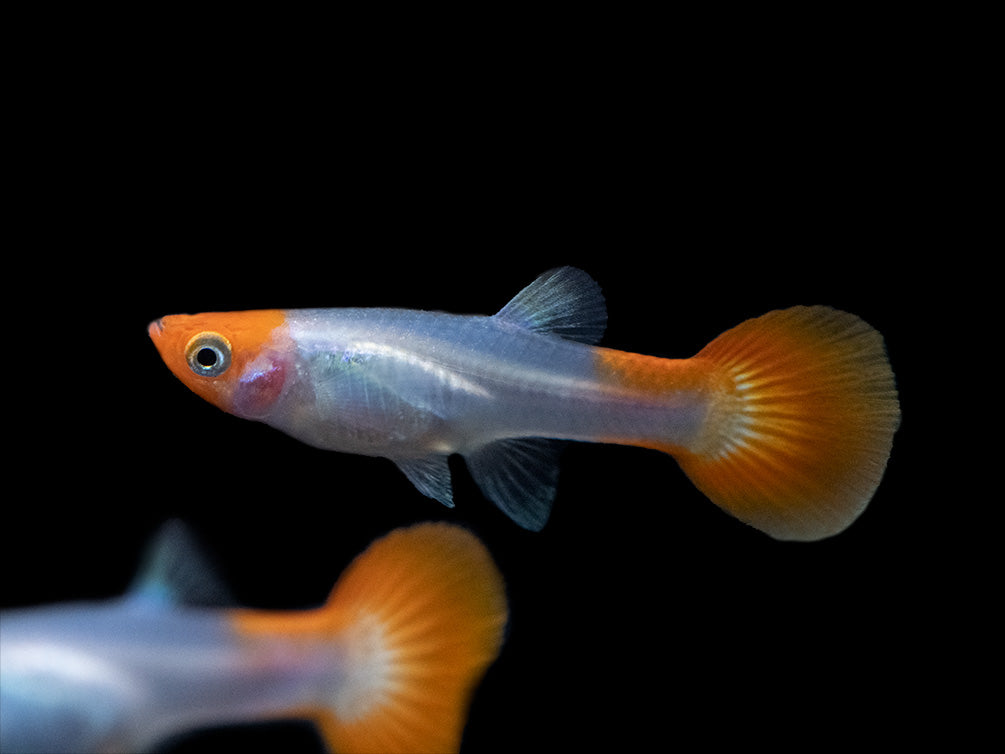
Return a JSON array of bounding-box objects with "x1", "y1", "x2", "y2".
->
[{"x1": 147, "y1": 310, "x2": 290, "y2": 418}]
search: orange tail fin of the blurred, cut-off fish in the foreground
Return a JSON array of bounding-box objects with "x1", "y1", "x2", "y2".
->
[{"x1": 318, "y1": 524, "x2": 507, "y2": 752}]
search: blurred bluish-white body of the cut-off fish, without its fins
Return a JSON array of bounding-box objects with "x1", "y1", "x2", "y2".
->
[{"x1": 0, "y1": 598, "x2": 340, "y2": 754}]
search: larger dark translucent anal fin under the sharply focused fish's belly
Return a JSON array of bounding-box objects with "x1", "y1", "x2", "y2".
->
[{"x1": 464, "y1": 437, "x2": 566, "y2": 532}]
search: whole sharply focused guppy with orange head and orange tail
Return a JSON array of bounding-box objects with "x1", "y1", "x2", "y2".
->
[{"x1": 149, "y1": 267, "x2": 899, "y2": 540}]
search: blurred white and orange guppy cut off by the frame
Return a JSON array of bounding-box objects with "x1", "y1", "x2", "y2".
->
[{"x1": 0, "y1": 523, "x2": 508, "y2": 754}]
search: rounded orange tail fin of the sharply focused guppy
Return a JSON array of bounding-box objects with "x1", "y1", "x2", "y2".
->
[{"x1": 673, "y1": 307, "x2": 899, "y2": 540}]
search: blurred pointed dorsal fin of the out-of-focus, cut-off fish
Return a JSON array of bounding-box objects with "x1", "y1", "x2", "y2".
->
[{"x1": 128, "y1": 520, "x2": 233, "y2": 606}]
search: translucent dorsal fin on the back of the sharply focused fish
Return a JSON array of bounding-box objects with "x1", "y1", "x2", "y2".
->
[{"x1": 495, "y1": 267, "x2": 607, "y2": 345}]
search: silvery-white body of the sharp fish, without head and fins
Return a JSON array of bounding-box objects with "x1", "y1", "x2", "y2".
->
[{"x1": 271, "y1": 309, "x2": 706, "y2": 460}]
